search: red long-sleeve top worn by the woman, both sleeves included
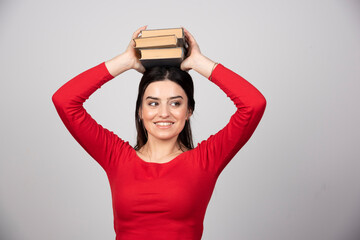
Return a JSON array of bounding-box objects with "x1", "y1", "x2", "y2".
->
[{"x1": 52, "y1": 62, "x2": 266, "y2": 240}]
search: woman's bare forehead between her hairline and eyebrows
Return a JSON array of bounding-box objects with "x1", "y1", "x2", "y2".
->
[{"x1": 144, "y1": 80, "x2": 186, "y2": 99}]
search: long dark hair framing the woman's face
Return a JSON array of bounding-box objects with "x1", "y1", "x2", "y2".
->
[{"x1": 134, "y1": 66, "x2": 195, "y2": 151}]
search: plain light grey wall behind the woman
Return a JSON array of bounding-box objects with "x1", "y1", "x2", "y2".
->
[{"x1": 0, "y1": 0, "x2": 360, "y2": 240}]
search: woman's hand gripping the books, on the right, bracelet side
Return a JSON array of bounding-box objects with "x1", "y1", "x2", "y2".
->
[{"x1": 180, "y1": 27, "x2": 202, "y2": 71}]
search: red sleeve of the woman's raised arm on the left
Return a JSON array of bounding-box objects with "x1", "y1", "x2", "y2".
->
[{"x1": 52, "y1": 62, "x2": 129, "y2": 171}]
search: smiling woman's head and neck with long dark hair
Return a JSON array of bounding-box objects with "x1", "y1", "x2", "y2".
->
[{"x1": 135, "y1": 66, "x2": 195, "y2": 159}]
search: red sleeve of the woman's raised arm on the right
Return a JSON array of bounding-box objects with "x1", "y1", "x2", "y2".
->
[{"x1": 198, "y1": 64, "x2": 266, "y2": 177}]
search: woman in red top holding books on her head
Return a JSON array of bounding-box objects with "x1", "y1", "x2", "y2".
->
[{"x1": 53, "y1": 26, "x2": 266, "y2": 240}]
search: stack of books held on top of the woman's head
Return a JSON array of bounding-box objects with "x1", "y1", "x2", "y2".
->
[{"x1": 133, "y1": 28, "x2": 188, "y2": 69}]
